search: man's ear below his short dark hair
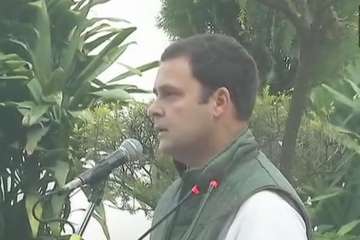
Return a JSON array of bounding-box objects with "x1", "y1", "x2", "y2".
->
[{"x1": 212, "y1": 87, "x2": 231, "y2": 118}]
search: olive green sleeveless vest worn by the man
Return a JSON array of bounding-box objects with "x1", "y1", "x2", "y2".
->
[{"x1": 150, "y1": 130, "x2": 311, "y2": 240}]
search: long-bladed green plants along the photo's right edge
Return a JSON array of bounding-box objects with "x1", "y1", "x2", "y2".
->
[{"x1": 306, "y1": 63, "x2": 360, "y2": 239}]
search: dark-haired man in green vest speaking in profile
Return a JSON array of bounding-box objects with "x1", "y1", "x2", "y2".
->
[{"x1": 148, "y1": 34, "x2": 311, "y2": 240}]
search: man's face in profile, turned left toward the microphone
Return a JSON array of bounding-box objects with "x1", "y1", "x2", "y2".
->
[{"x1": 148, "y1": 57, "x2": 214, "y2": 163}]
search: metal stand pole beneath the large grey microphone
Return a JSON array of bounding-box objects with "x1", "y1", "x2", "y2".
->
[{"x1": 77, "y1": 181, "x2": 105, "y2": 237}]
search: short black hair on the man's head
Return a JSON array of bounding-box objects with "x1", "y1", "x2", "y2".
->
[{"x1": 161, "y1": 33, "x2": 260, "y2": 120}]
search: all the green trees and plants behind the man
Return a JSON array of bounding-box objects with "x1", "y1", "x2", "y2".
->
[{"x1": 0, "y1": 0, "x2": 360, "y2": 240}]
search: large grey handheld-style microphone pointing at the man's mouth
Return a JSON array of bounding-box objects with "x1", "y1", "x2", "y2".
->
[{"x1": 61, "y1": 138, "x2": 143, "y2": 192}]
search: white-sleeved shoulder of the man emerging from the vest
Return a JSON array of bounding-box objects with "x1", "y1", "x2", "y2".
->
[{"x1": 226, "y1": 190, "x2": 307, "y2": 240}]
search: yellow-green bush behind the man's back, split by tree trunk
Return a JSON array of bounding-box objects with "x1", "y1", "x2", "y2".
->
[{"x1": 250, "y1": 88, "x2": 346, "y2": 193}]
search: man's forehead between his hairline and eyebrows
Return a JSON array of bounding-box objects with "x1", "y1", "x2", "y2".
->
[{"x1": 154, "y1": 57, "x2": 199, "y2": 89}]
